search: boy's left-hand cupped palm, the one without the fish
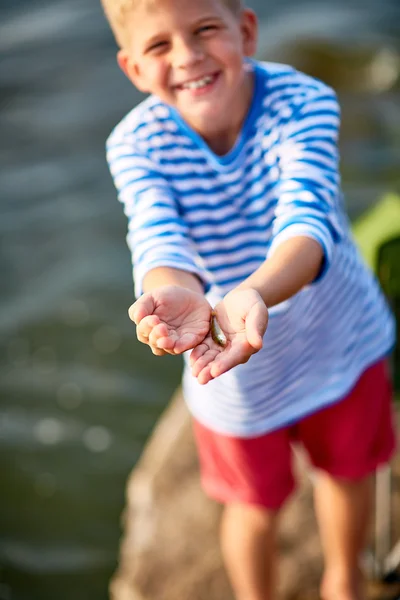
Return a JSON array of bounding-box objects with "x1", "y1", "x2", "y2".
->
[{"x1": 129, "y1": 285, "x2": 211, "y2": 356}]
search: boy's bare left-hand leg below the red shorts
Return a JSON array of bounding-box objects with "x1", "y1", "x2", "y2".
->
[{"x1": 221, "y1": 503, "x2": 277, "y2": 600}]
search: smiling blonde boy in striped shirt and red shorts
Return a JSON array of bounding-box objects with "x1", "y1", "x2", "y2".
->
[{"x1": 103, "y1": 0, "x2": 395, "y2": 600}]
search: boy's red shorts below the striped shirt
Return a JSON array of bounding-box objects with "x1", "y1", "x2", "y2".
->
[{"x1": 194, "y1": 360, "x2": 396, "y2": 510}]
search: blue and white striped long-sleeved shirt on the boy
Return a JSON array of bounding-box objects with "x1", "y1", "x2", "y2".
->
[{"x1": 107, "y1": 61, "x2": 394, "y2": 437}]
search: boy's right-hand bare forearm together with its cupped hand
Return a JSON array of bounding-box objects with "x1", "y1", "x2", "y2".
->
[{"x1": 190, "y1": 236, "x2": 323, "y2": 384}]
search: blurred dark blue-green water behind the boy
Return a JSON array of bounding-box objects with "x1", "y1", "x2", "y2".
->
[{"x1": 0, "y1": 0, "x2": 400, "y2": 600}]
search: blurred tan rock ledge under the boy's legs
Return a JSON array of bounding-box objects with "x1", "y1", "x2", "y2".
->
[{"x1": 110, "y1": 390, "x2": 400, "y2": 600}]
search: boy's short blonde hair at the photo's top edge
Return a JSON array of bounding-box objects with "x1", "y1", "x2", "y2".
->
[{"x1": 100, "y1": 0, "x2": 243, "y2": 48}]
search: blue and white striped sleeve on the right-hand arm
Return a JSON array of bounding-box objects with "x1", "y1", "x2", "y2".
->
[{"x1": 269, "y1": 86, "x2": 344, "y2": 279}]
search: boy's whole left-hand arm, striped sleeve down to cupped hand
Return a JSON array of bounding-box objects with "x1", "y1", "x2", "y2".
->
[{"x1": 107, "y1": 135, "x2": 211, "y2": 355}]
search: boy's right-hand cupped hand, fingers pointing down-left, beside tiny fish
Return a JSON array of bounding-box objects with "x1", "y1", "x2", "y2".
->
[{"x1": 190, "y1": 289, "x2": 268, "y2": 384}]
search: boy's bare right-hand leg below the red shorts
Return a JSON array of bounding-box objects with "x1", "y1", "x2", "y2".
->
[{"x1": 314, "y1": 472, "x2": 372, "y2": 600}]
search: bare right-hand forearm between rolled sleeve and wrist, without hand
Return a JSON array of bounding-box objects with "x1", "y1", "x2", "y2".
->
[{"x1": 238, "y1": 236, "x2": 324, "y2": 308}]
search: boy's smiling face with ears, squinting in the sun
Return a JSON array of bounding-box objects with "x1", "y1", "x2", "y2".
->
[{"x1": 118, "y1": 0, "x2": 257, "y2": 141}]
